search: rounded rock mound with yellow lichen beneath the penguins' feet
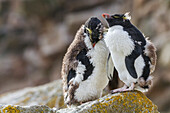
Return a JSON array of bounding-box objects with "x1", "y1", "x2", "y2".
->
[{"x1": 57, "y1": 91, "x2": 158, "y2": 113}]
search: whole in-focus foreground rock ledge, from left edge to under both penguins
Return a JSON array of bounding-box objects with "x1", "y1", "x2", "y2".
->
[{"x1": 0, "y1": 90, "x2": 159, "y2": 113}]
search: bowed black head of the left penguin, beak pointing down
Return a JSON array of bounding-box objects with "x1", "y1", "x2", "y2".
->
[{"x1": 84, "y1": 17, "x2": 103, "y2": 47}]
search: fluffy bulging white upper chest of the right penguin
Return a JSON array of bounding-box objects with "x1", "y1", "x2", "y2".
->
[{"x1": 105, "y1": 25, "x2": 134, "y2": 56}]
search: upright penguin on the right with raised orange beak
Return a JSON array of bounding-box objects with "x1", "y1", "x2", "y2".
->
[{"x1": 102, "y1": 13, "x2": 157, "y2": 93}]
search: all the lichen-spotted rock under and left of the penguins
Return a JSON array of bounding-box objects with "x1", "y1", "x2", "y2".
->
[{"x1": 0, "y1": 80, "x2": 159, "y2": 113}]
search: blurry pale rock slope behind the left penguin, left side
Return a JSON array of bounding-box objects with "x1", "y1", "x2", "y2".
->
[{"x1": 0, "y1": 80, "x2": 64, "y2": 108}]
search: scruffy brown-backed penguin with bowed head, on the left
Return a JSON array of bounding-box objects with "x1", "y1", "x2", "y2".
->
[{"x1": 61, "y1": 17, "x2": 113, "y2": 107}]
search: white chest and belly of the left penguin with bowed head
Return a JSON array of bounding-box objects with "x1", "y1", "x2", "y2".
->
[{"x1": 75, "y1": 40, "x2": 109, "y2": 101}]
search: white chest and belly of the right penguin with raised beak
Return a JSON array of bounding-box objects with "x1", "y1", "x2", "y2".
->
[{"x1": 105, "y1": 26, "x2": 137, "y2": 85}]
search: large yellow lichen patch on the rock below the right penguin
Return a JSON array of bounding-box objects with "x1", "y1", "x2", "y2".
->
[{"x1": 90, "y1": 91, "x2": 157, "y2": 113}]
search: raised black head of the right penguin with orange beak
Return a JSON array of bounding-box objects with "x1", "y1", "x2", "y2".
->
[{"x1": 102, "y1": 12, "x2": 131, "y2": 27}]
